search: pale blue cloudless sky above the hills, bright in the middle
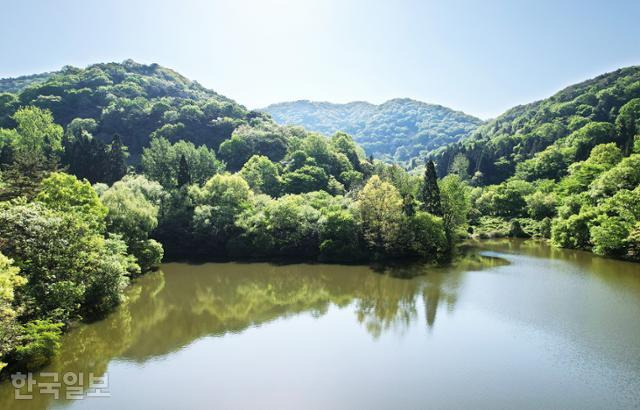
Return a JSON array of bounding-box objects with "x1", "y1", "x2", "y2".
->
[{"x1": 0, "y1": 0, "x2": 640, "y2": 118}]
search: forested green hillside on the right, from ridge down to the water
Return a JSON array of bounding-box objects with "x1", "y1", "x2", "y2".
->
[{"x1": 431, "y1": 67, "x2": 640, "y2": 261}]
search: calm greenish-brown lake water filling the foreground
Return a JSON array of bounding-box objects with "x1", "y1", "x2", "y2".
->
[{"x1": 0, "y1": 241, "x2": 640, "y2": 410}]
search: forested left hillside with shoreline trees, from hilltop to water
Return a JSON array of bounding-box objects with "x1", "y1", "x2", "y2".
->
[{"x1": 0, "y1": 61, "x2": 471, "y2": 373}]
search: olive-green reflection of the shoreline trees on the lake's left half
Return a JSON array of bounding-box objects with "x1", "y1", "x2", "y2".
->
[{"x1": 0, "y1": 251, "x2": 504, "y2": 409}]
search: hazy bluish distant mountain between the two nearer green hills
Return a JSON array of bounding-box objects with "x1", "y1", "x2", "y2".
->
[{"x1": 262, "y1": 98, "x2": 482, "y2": 166}]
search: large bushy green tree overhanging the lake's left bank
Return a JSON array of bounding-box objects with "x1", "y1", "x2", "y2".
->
[{"x1": 0, "y1": 203, "x2": 130, "y2": 322}]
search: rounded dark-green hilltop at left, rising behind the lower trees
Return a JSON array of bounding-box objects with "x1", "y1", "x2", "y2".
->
[{"x1": 0, "y1": 60, "x2": 266, "y2": 159}]
